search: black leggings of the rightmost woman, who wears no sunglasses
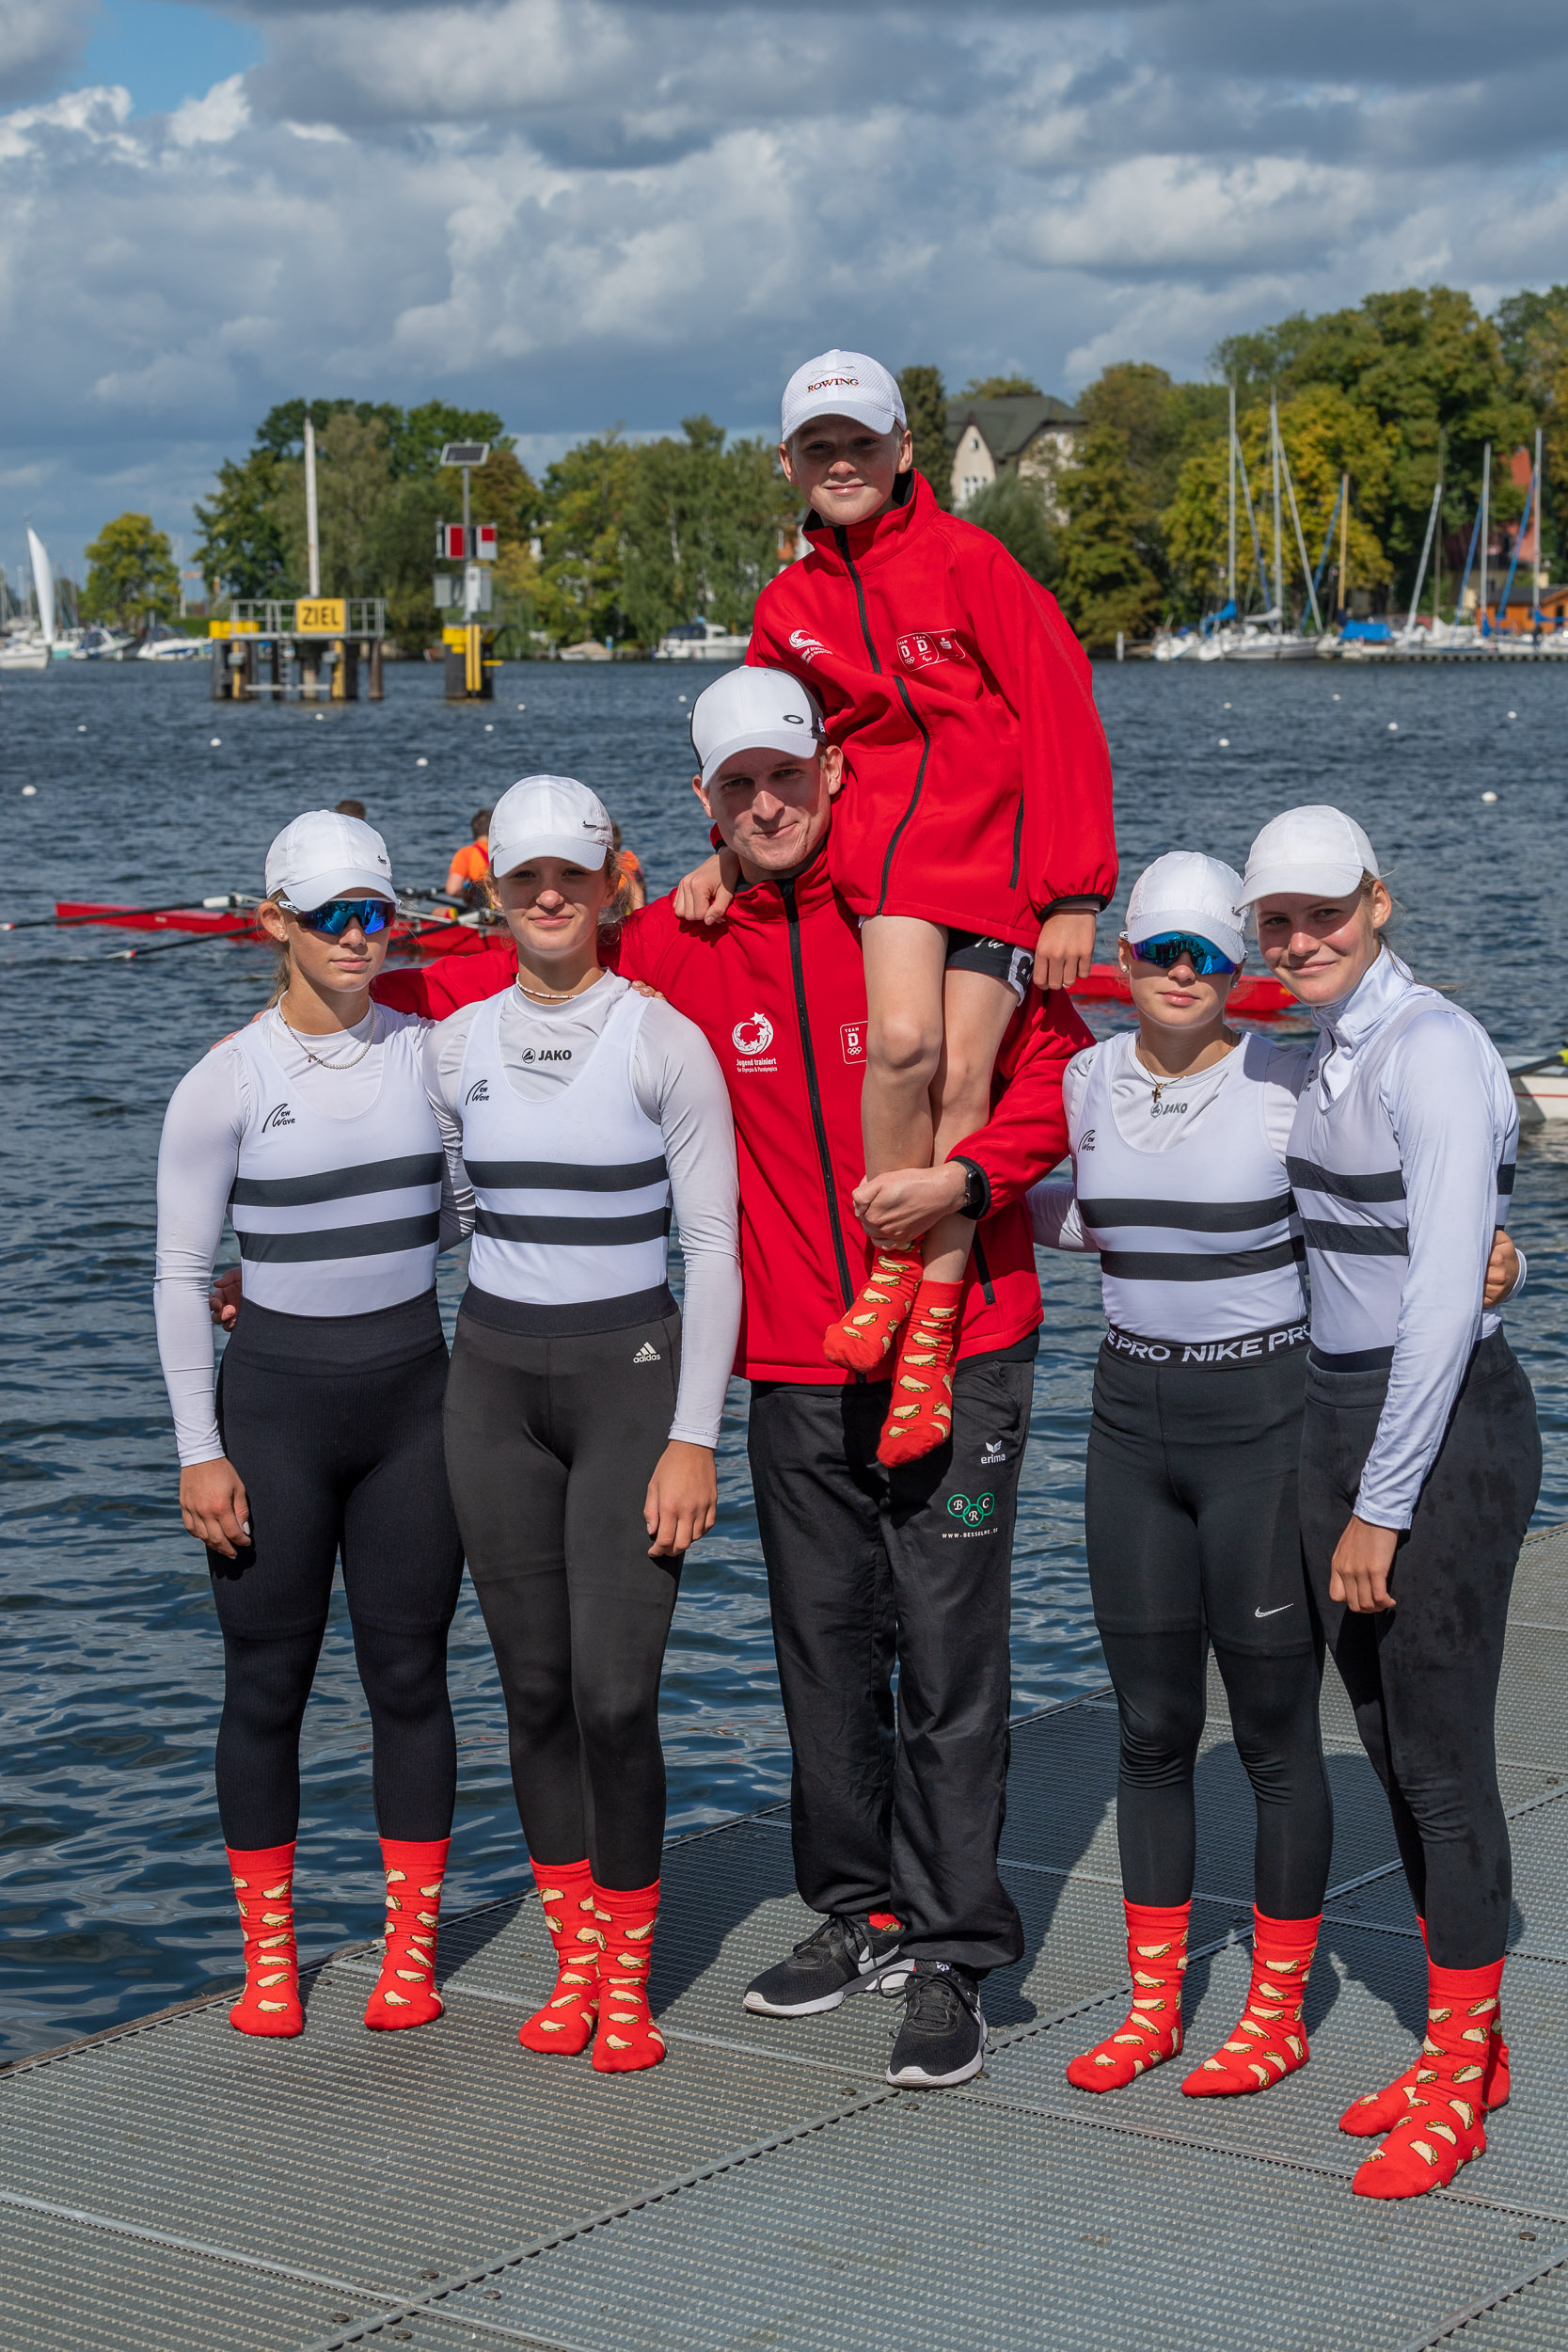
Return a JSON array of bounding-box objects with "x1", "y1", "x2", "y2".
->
[{"x1": 1303, "y1": 1331, "x2": 1540, "y2": 1969}]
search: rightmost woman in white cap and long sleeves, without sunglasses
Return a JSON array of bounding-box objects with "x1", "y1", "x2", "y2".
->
[{"x1": 1242, "y1": 807, "x2": 1540, "y2": 2200}]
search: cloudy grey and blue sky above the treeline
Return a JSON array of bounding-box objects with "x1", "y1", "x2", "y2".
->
[{"x1": 0, "y1": 0, "x2": 1568, "y2": 577}]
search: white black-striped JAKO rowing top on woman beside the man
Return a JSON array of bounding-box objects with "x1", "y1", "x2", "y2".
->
[{"x1": 458, "y1": 991, "x2": 670, "y2": 1320}]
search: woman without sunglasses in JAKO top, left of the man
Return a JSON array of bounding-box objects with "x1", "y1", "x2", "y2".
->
[{"x1": 425, "y1": 776, "x2": 740, "y2": 2073}]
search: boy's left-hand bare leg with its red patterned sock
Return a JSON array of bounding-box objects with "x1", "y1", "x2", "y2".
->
[{"x1": 823, "y1": 915, "x2": 947, "y2": 1372}]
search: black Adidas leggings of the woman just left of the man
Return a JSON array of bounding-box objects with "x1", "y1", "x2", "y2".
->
[{"x1": 447, "y1": 1294, "x2": 682, "y2": 1886}]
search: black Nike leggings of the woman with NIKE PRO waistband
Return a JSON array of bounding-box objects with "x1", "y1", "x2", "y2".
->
[{"x1": 1084, "y1": 1345, "x2": 1333, "y2": 1919}]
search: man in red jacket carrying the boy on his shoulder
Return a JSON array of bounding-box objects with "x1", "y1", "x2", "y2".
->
[{"x1": 376, "y1": 675, "x2": 1088, "y2": 2084}]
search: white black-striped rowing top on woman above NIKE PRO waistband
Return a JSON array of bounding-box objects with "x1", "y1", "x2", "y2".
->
[{"x1": 1069, "y1": 1030, "x2": 1307, "y2": 1343}]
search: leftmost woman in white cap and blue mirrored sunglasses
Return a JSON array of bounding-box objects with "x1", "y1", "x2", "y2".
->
[{"x1": 155, "y1": 809, "x2": 463, "y2": 2035}]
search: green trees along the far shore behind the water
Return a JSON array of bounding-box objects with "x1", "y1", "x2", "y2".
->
[{"x1": 82, "y1": 285, "x2": 1568, "y2": 659}]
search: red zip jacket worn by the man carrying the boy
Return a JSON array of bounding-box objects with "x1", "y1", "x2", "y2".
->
[{"x1": 373, "y1": 854, "x2": 1088, "y2": 1388}]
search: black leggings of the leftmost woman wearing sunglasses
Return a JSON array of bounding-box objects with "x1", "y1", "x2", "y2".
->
[{"x1": 207, "y1": 1292, "x2": 463, "y2": 1849}]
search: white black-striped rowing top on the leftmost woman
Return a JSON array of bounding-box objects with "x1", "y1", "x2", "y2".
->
[{"x1": 228, "y1": 1014, "x2": 442, "y2": 1315}]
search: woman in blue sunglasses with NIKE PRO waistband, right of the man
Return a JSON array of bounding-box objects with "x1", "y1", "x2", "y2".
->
[{"x1": 1030, "y1": 851, "x2": 1523, "y2": 2098}]
